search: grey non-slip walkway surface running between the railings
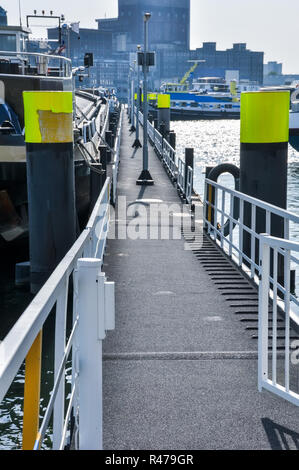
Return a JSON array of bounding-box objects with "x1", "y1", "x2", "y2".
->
[{"x1": 103, "y1": 116, "x2": 299, "y2": 450}]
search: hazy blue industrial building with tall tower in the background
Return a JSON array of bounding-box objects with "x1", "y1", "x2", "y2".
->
[{"x1": 48, "y1": 0, "x2": 264, "y2": 99}]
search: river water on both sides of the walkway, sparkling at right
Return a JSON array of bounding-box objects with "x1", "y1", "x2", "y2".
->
[{"x1": 0, "y1": 120, "x2": 299, "y2": 450}]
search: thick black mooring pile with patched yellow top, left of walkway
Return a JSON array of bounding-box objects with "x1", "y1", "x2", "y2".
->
[{"x1": 23, "y1": 91, "x2": 76, "y2": 294}]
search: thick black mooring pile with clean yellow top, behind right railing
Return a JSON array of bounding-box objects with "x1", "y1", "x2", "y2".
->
[{"x1": 240, "y1": 91, "x2": 290, "y2": 280}]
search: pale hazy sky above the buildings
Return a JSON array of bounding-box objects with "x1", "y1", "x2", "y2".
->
[{"x1": 0, "y1": 0, "x2": 299, "y2": 73}]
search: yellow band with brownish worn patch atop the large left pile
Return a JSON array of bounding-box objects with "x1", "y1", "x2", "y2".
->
[{"x1": 23, "y1": 91, "x2": 73, "y2": 143}]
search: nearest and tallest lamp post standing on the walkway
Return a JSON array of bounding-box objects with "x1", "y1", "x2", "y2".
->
[{"x1": 136, "y1": 13, "x2": 154, "y2": 186}]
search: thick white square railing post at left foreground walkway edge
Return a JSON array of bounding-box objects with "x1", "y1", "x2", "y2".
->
[{"x1": 77, "y1": 259, "x2": 105, "y2": 450}]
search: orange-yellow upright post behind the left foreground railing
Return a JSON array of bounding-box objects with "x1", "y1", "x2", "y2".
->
[{"x1": 23, "y1": 331, "x2": 42, "y2": 450}]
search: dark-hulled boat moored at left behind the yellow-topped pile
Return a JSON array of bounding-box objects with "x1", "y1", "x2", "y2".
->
[{"x1": 0, "y1": 46, "x2": 109, "y2": 247}]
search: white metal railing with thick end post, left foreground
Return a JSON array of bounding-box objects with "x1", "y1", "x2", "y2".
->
[{"x1": 0, "y1": 178, "x2": 114, "y2": 449}]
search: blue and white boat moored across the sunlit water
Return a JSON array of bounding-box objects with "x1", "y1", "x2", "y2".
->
[{"x1": 162, "y1": 77, "x2": 240, "y2": 120}]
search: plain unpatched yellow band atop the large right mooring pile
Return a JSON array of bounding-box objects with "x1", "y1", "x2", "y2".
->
[{"x1": 241, "y1": 91, "x2": 290, "y2": 144}]
